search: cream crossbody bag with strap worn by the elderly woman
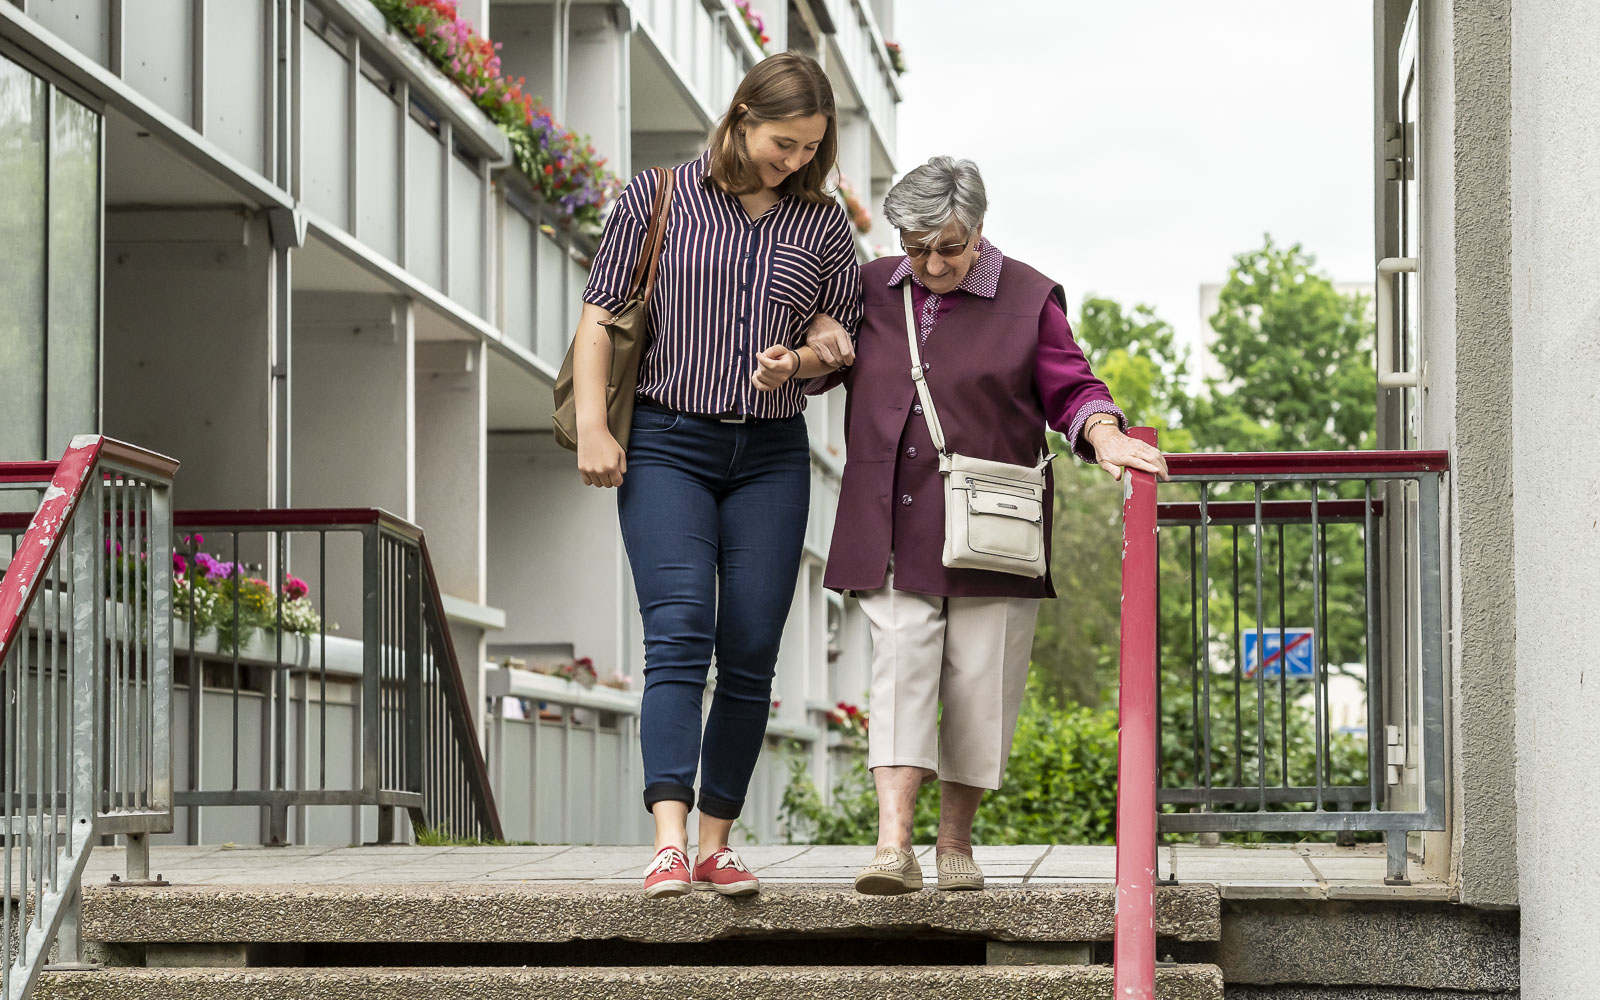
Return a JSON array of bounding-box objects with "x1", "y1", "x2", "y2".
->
[{"x1": 906, "y1": 280, "x2": 1054, "y2": 578}]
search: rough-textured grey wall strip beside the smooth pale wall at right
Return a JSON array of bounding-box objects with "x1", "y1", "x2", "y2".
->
[{"x1": 1424, "y1": 0, "x2": 1520, "y2": 906}]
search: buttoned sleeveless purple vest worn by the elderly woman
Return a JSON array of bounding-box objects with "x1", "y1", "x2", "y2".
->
[{"x1": 822, "y1": 258, "x2": 1066, "y2": 597}]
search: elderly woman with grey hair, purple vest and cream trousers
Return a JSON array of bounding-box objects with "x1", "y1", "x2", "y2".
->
[{"x1": 796, "y1": 157, "x2": 1166, "y2": 894}]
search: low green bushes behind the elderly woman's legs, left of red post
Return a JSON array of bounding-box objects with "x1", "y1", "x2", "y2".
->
[{"x1": 779, "y1": 675, "x2": 1117, "y2": 845}]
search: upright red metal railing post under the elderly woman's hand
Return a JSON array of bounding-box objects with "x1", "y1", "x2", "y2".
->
[{"x1": 1112, "y1": 427, "x2": 1158, "y2": 1000}]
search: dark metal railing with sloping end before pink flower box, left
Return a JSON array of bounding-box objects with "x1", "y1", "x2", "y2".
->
[{"x1": 174, "y1": 509, "x2": 502, "y2": 845}]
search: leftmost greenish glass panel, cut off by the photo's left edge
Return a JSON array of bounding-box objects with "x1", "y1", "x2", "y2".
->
[{"x1": 0, "y1": 58, "x2": 48, "y2": 461}]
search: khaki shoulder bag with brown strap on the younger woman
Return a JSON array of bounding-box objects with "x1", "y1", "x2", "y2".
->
[{"x1": 552, "y1": 166, "x2": 672, "y2": 451}]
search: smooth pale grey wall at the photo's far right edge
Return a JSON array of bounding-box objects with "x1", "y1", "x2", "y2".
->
[{"x1": 1509, "y1": 0, "x2": 1600, "y2": 1000}]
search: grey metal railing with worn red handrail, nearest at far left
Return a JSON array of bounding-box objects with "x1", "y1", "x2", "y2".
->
[{"x1": 0, "y1": 435, "x2": 178, "y2": 1000}]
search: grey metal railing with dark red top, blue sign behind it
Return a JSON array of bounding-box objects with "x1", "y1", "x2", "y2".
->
[{"x1": 1130, "y1": 451, "x2": 1448, "y2": 882}]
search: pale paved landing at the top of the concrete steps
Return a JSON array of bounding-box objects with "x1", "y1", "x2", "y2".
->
[{"x1": 88, "y1": 845, "x2": 1450, "y2": 899}]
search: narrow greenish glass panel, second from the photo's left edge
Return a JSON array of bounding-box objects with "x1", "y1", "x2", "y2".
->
[{"x1": 45, "y1": 91, "x2": 101, "y2": 456}]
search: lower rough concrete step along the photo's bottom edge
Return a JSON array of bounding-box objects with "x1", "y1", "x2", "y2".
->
[{"x1": 37, "y1": 965, "x2": 1222, "y2": 1000}]
